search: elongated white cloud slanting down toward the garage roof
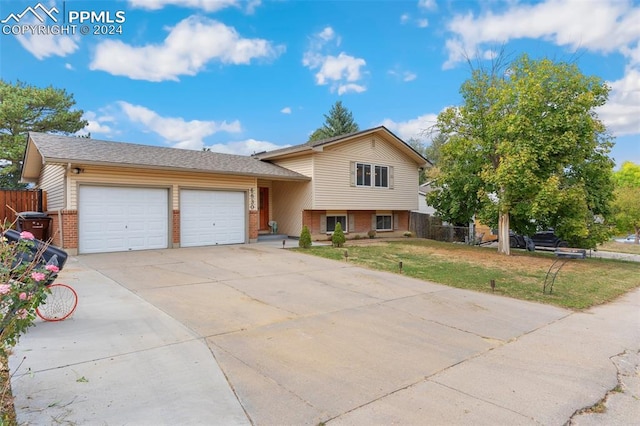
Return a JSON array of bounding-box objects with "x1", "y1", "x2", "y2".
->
[{"x1": 118, "y1": 101, "x2": 242, "y2": 149}]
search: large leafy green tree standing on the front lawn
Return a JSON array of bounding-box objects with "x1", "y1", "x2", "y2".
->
[{"x1": 429, "y1": 55, "x2": 613, "y2": 254}]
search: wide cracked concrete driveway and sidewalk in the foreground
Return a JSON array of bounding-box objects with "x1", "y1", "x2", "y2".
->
[{"x1": 11, "y1": 242, "x2": 640, "y2": 425}]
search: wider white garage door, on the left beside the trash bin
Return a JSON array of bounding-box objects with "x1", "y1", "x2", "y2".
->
[{"x1": 78, "y1": 186, "x2": 169, "y2": 253}]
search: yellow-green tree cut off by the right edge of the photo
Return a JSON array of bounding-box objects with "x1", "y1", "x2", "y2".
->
[{"x1": 613, "y1": 161, "x2": 640, "y2": 244}]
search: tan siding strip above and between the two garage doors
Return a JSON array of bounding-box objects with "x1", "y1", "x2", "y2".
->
[{"x1": 68, "y1": 166, "x2": 257, "y2": 210}]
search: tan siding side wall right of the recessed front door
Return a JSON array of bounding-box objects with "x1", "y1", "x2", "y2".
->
[{"x1": 271, "y1": 181, "x2": 311, "y2": 236}]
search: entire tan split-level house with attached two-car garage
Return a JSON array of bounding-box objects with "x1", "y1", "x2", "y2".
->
[{"x1": 22, "y1": 127, "x2": 426, "y2": 254}]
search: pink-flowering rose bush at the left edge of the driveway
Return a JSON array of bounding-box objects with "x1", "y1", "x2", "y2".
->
[{"x1": 0, "y1": 228, "x2": 59, "y2": 356}]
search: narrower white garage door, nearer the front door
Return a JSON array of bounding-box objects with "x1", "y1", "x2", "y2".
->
[{"x1": 180, "y1": 189, "x2": 246, "y2": 247}]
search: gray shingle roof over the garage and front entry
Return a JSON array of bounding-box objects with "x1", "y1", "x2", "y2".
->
[{"x1": 29, "y1": 132, "x2": 309, "y2": 180}]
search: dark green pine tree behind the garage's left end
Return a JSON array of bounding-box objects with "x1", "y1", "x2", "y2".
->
[{"x1": 0, "y1": 80, "x2": 87, "y2": 188}]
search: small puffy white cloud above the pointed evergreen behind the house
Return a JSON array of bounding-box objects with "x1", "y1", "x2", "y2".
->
[{"x1": 302, "y1": 27, "x2": 366, "y2": 94}]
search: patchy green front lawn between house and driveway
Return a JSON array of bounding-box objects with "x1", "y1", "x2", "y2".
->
[{"x1": 295, "y1": 239, "x2": 640, "y2": 309}]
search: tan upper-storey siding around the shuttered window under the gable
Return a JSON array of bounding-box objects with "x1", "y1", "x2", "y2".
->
[{"x1": 312, "y1": 136, "x2": 418, "y2": 210}]
